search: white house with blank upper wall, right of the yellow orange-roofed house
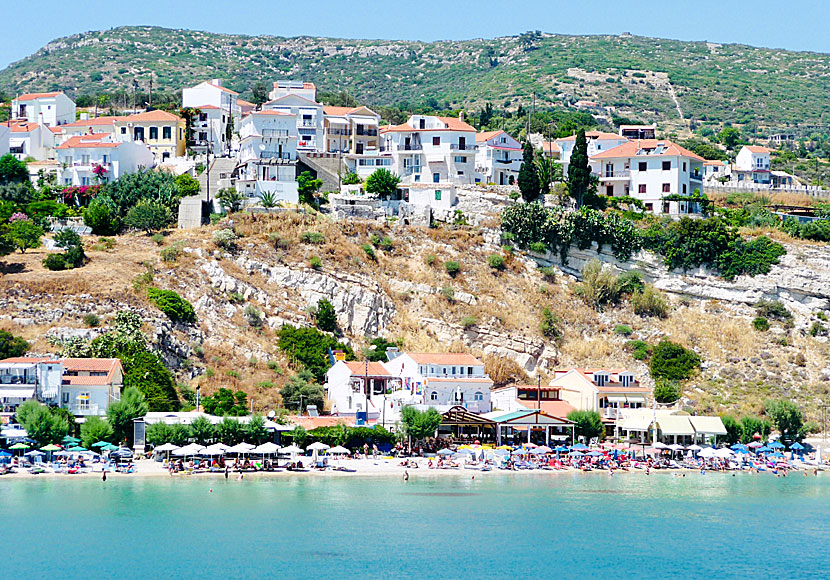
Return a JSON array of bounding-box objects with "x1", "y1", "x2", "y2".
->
[{"x1": 182, "y1": 79, "x2": 242, "y2": 157}]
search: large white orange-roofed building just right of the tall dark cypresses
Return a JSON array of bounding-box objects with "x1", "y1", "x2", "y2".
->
[{"x1": 590, "y1": 139, "x2": 704, "y2": 214}]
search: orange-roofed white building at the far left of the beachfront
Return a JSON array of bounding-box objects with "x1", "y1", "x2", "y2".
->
[{"x1": 0, "y1": 357, "x2": 124, "y2": 422}]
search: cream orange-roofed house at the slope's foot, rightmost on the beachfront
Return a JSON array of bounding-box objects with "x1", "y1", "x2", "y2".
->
[{"x1": 549, "y1": 368, "x2": 651, "y2": 425}]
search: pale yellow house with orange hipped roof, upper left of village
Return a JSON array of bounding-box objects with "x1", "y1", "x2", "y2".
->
[{"x1": 115, "y1": 109, "x2": 187, "y2": 164}]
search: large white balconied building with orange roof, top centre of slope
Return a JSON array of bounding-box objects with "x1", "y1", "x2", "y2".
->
[{"x1": 381, "y1": 115, "x2": 477, "y2": 189}]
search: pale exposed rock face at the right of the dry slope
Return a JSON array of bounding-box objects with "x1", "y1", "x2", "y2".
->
[{"x1": 534, "y1": 244, "x2": 830, "y2": 316}]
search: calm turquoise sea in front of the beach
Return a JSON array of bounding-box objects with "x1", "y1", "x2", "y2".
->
[{"x1": 0, "y1": 472, "x2": 830, "y2": 580}]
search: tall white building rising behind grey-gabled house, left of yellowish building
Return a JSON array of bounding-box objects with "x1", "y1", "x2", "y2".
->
[{"x1": 262, "y1": 81, "x2": 326, "y2": 152}]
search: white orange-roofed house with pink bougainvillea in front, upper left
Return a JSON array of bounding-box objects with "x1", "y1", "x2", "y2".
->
[{"x1": 56, "y1": 133, "x2": 154, "y2": 185}]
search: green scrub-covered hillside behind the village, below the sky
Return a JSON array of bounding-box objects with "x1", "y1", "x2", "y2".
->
[{"x1": 0, "y1": 27, "x2": 830, "y2": 131}]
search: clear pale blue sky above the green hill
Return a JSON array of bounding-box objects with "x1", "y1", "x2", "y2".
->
[{"x1": 0, "y1": 0, "x2": 830, "y2": 68}]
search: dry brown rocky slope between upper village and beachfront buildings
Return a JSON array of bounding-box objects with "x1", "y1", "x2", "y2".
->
[{"x1": 0, "y1": 207, "x2": 830, "y2": 418}]
